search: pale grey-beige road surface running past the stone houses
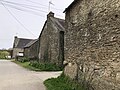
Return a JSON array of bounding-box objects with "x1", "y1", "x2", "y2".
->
[{"x1": 0, "y1": 60, "x2": 61, "y2": 90}]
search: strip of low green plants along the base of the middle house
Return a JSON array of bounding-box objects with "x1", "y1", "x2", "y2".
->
[{"x1": 14, "y1": 57, "x2": 63, "y2": 71}]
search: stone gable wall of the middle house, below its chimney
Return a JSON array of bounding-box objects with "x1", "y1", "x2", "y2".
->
[{"x1": 40, "y1": 20, "x2": 59, "y2": 63}]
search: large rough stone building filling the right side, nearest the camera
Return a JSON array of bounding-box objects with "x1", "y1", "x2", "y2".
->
[{"x1": 64, "y1": 0, "x2": 120, "y2": 90}]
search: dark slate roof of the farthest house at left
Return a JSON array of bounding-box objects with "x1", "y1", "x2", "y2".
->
[{"x1": 13, "y1": 38, "x2": 33, "y2": 49}]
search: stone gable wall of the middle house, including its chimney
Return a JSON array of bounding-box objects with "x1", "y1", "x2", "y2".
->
[{"x1": 39, "y1": 13, "x2": 62, "y2": 65}]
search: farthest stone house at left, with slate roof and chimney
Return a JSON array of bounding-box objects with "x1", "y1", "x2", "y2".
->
[{"x1": 12, "y1": 36, "x2": 32, "y2": 58}]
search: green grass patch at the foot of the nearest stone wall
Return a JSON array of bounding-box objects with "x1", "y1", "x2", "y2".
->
[{"x1": 44, "y1": 75, "x2": 85, "y2": 90}]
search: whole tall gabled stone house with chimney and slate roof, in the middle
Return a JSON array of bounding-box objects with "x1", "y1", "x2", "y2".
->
[{"x1": 39, "y1": 12, "x2": 65, "y2": 66}]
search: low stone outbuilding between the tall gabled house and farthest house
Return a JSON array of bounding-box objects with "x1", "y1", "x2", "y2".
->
[{"x1": 24, "y1": 39, "x2": 39, "y2": 60}]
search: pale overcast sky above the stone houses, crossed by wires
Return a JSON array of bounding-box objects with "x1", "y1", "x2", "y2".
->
[{"x1": 0, "y1": 0, "x2": 73, "y2": 49}]
